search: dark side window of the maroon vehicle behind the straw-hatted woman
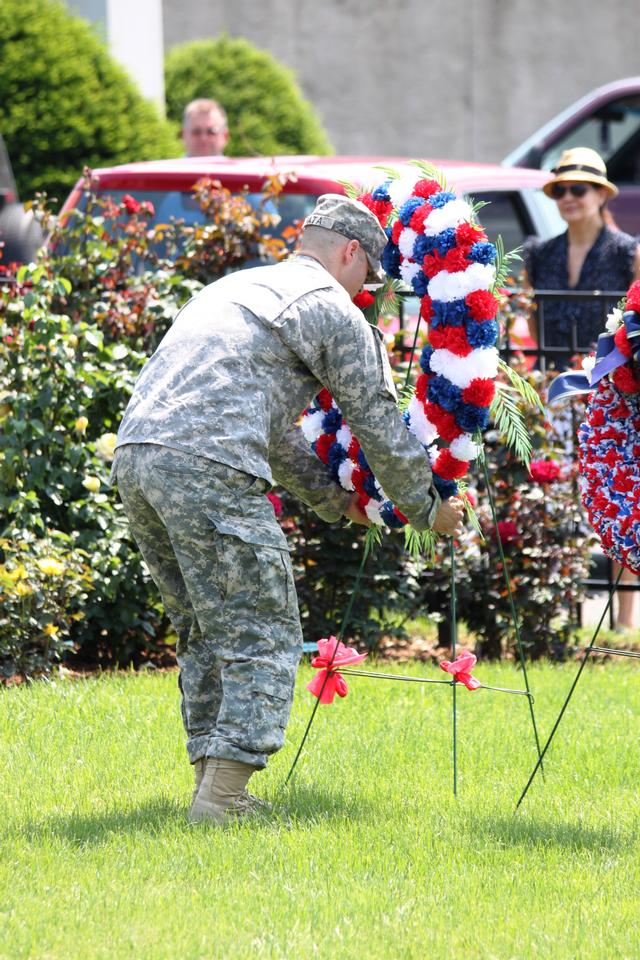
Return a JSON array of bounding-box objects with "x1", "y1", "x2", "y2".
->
[{"x1": 540, "y1": 94, "x2": 640, "y2": 183}]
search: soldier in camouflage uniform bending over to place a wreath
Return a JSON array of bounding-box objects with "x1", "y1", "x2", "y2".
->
[{"x1": 113, "y1": 194, "x2": 462, "y2": 823}]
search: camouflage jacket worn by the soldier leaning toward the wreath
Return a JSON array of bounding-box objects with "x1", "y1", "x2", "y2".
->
[{"x1": 117, "y1": 256, "x2": 440, "y2": 529}]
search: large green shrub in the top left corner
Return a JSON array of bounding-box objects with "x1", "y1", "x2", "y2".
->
[{"x1": 0, "y1": 0, "x2": 181, "y2": 199}]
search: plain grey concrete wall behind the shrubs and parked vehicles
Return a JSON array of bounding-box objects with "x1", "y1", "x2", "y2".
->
[{"x1": 163, "y1": 0, "x2": 640, "y2": 160}]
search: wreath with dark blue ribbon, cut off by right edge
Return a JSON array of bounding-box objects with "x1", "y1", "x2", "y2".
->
[{"x1": 568, "y1": 281, "x2": 640, "y2": 574}]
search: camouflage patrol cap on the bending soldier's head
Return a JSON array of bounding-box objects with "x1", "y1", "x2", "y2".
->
[{"x1": 303, "y1": 193, "x2": 387, "y2": 283}]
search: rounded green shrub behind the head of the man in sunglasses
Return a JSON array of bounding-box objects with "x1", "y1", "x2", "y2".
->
[{"x1": 165, "y1": 35, "x2": 330, "y2": 156}]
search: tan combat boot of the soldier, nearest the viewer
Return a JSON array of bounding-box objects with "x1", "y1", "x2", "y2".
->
[{"x1": 189, "y1": 757, "x2": 262, "y2": 823}]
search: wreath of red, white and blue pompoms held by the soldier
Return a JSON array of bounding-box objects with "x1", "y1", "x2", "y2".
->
[{"x1": 302, "y1": 164, "x2": 499, "y2": 527}]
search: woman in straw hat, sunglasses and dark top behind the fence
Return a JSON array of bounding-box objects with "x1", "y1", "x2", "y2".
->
[{"x1": 525, "y1": 147, "x2": 640, "y2": 369}]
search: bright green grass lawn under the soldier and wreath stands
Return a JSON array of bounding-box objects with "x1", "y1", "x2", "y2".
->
[{"x1": 0, "y1": 663, "x2": 640, "y2": 960}]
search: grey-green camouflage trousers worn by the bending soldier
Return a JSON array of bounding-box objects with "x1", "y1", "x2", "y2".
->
[{"x1": 113, "y1": 444, "x2": 302, "y2": 767}]
